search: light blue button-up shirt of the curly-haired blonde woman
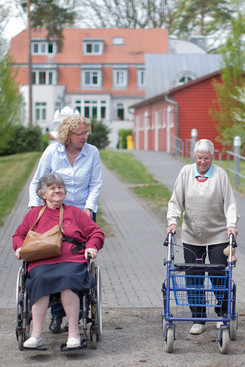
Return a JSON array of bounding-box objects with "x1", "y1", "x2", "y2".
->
[{"x1": 28, "y1": 143, "x2": 102, "y2": 212}]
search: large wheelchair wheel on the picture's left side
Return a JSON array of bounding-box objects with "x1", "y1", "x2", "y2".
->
[{"x1": 16, "y1": 266, "x2": 31, "y2": 350}]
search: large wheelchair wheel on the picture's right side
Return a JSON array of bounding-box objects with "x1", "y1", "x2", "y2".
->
[{"x1": 90, "y1": 262, "x2": 102, "y2": 349}]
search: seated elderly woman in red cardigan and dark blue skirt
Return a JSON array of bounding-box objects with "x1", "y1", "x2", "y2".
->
[{"x1": 13, "y1": 173, "x2": 104, "y2": 349}]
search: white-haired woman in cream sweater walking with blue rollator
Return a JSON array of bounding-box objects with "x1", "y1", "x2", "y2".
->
[{"x1": 166, "y1": 139, "x2": 239, "y2": 334}]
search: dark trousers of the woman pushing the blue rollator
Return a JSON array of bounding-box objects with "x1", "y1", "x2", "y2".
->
[{"x1": 183, "y1": 243, "x2": 229, "y2": 324}]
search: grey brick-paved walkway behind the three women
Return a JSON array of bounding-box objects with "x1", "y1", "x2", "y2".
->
[{"x1": 0, "y1": 151, "x2": 245, "y2": 310}]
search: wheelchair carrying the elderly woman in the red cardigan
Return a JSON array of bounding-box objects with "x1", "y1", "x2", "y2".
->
[{"x1": 16, "y1": 258, "x2": 102, "y2": 352}]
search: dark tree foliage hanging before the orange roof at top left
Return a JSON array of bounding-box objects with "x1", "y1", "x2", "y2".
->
[{"x1": 21, "y1": 0, "x2": 76, "y2": 51}]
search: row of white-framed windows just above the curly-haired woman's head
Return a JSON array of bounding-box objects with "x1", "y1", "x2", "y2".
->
[{"x1": 75, "y1": 99, "x2": 107, "y2": 120}]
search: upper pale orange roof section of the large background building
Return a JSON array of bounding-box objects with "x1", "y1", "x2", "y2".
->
[{"x1": 10, "y1": 28, "x2": 168, "y2": 64}]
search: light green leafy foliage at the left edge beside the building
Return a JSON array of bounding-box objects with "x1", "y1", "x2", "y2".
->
[{"x1": 0, "y1": 54, "x2": 22, "y2": 153}]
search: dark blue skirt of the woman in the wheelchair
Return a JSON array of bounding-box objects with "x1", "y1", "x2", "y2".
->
[{"x1": 26, "y1": 262, "x2": 96, "y2": 306}]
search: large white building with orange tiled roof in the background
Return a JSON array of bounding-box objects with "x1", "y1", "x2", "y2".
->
[{"x1": 10, "y1": 29, "x2": 168, "y2": 142}]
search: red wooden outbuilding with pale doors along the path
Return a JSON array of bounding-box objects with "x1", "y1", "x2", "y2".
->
[{"x1": 131, "y1": 72, "x2": 225, "y2": 154}]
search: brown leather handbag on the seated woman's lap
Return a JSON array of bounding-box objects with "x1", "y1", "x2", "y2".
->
[{"x1": 20, "y1": 205, "x2": 64, "y2": 261}]
